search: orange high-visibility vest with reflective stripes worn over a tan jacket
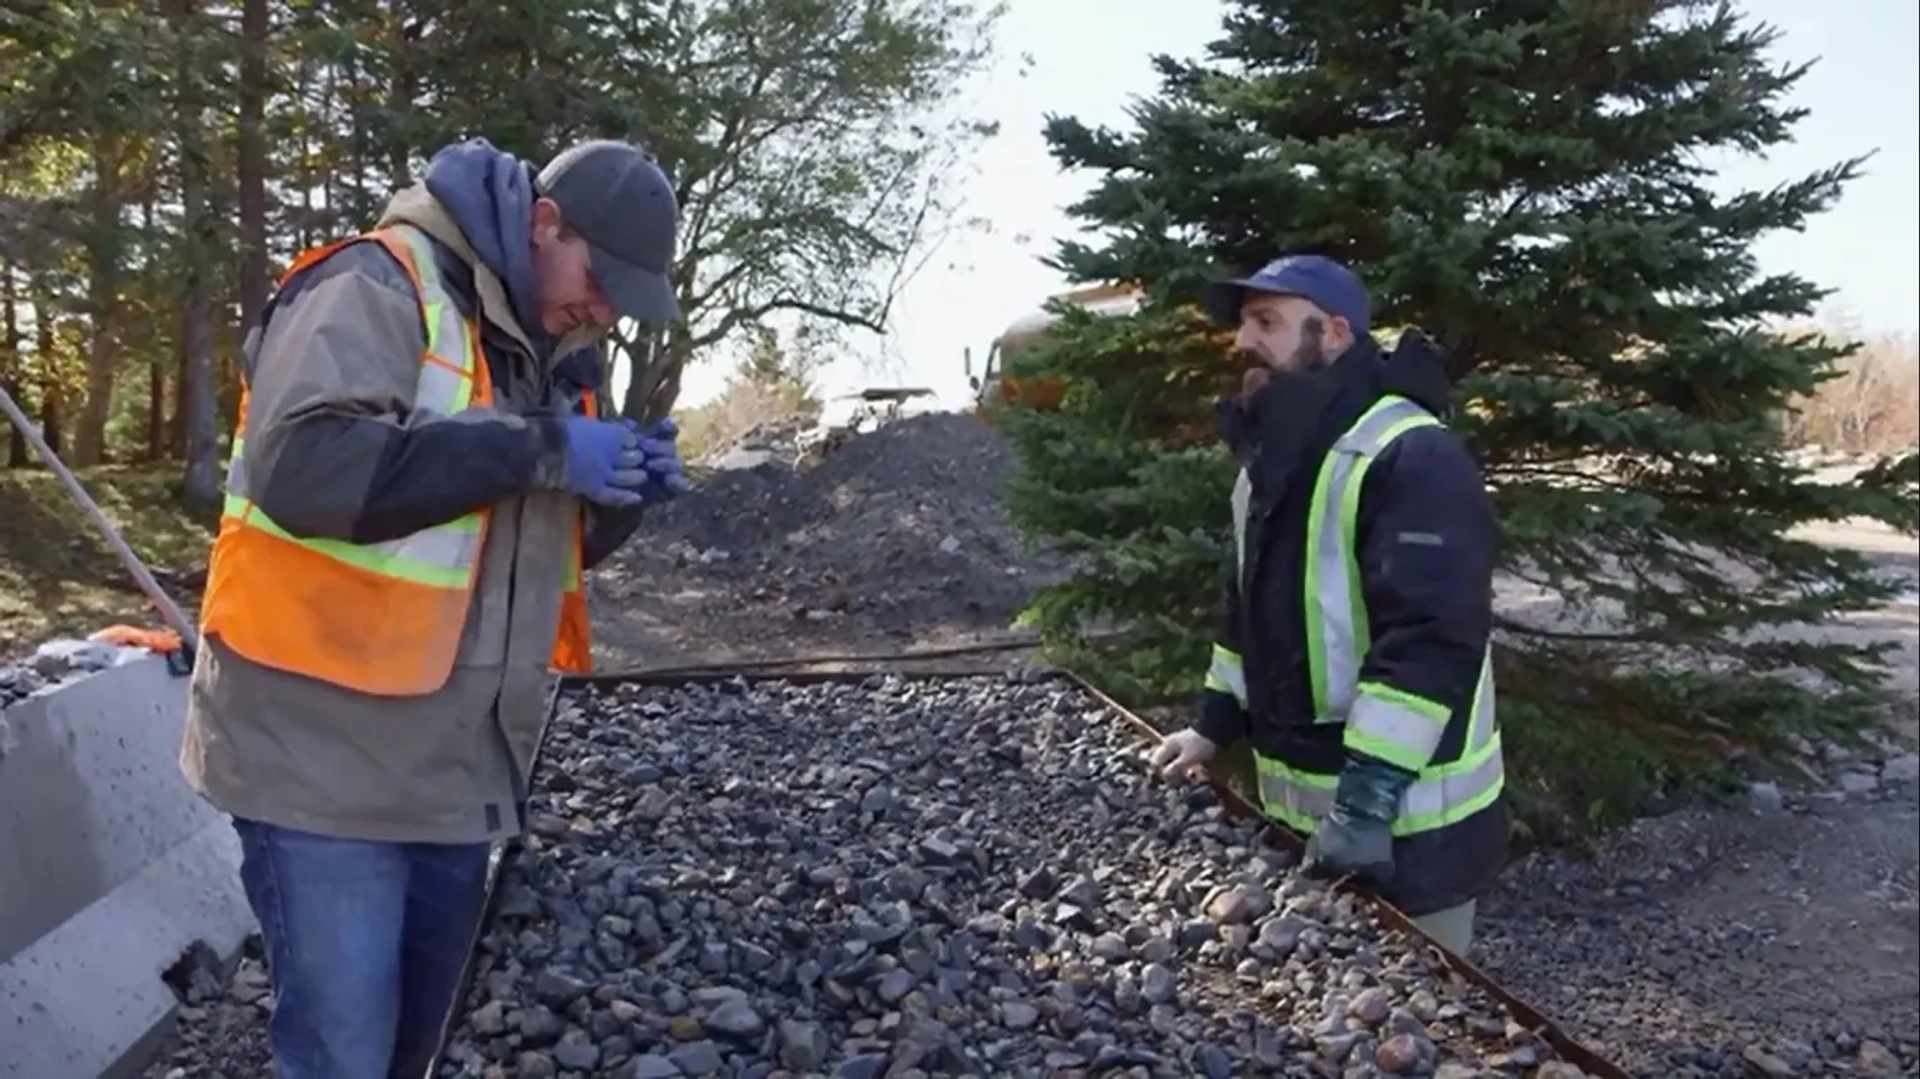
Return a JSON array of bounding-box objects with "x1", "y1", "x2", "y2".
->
[{"x1": 200, "y1": 225, "x2": 597, "y2": 697}]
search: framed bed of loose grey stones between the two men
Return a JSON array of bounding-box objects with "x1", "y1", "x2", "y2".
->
[{"x1": 440, "y1": 678, "x2": 1582, "y2": 1079}]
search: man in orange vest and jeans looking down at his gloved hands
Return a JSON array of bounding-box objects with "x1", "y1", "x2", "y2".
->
[{"x1": 180, "y1": 140, "x2": 685, "y2": 1079}]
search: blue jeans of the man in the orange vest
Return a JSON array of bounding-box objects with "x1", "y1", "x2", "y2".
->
[{"x1": 234, "y1": 818, "x2": 488, "y2": 1079}]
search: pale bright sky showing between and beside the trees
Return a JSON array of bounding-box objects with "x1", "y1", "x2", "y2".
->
[{"x1": 648, "y1": 0, "x2": 1920, "y2": 407}]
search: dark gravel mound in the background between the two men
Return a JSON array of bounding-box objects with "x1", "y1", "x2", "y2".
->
[{"x1": 599, "y1": 413, "x2": 1060, "y2": 632}]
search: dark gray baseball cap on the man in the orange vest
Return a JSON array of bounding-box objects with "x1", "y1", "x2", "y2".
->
[{"x1": 534, "y1": 138, "x2": 680, "y2": 323}]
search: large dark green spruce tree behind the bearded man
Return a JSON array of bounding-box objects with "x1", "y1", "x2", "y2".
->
[{"x1": 1004, "y1": 0, "x2": 1920, "y2": 837}]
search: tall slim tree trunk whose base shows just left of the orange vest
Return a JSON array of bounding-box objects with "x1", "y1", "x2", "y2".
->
[{"x1": 173, "y1": 0, "x2": 221, "y2": 509}]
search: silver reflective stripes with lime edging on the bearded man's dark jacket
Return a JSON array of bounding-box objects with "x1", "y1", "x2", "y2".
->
[{"x1": 1210, "y1": 397, "x2": 1505, "y2": 835}]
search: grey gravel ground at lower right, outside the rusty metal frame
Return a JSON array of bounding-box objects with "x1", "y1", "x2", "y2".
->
[{"x1": 1480, "y1": 755, "x2": 1920, "y2": 1079}]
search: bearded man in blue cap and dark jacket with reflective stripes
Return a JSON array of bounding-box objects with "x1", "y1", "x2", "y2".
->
[{"x1": 1154, "y1": 255, "x2": 1507, "y2": 954}]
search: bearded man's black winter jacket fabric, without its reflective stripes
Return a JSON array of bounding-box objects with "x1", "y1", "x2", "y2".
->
[{"x1": 1196, "y1": 334, "x2": 1507, "y2": 916}]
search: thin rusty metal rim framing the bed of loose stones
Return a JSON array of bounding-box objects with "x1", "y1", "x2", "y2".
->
[{"x1": 439, "y1": 656, "x2": 1634, "y2": 1079}]
